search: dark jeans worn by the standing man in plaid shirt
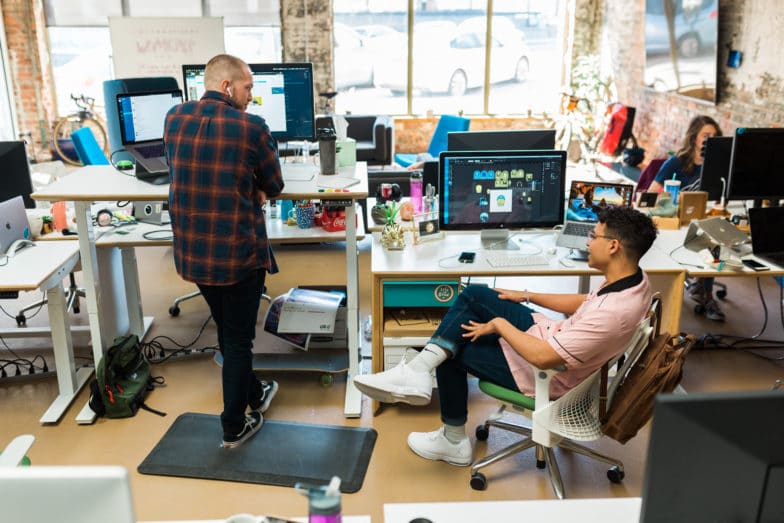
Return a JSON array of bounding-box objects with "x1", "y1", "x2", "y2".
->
[{"x1": 199, "y1": 269, "x2": 267, "y2": 434}]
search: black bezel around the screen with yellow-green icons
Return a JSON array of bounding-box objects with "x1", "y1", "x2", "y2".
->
[{"x1": 438, "y1": 149, "x2": 566, "y2": 232}]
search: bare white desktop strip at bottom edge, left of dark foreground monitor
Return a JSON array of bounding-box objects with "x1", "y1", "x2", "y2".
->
[{"x1": 384, "y1": 498, "x2": 642, "y2": 523}]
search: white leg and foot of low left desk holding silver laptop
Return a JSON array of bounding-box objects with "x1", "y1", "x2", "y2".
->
[{"x1": 40, "y1": 283, "x2": 92, "y2": 423}]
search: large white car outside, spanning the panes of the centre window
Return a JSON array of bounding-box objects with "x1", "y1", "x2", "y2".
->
[{"x1": 374, "y1": 17, "x2": 530, "y2": 97}]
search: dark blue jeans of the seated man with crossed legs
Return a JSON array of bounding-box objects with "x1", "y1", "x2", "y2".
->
[{"x1": 430, "y1": 285, "x2": 534, "y2": 425}]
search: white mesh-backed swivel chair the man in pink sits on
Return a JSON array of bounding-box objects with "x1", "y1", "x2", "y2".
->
[{"x1": 471, "y1": 293, "x2": 661, "y2": 499}]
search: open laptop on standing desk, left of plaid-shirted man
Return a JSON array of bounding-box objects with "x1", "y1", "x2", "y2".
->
[{"x1": 117, "y1": 89, "x2": 182, "y2": 181}]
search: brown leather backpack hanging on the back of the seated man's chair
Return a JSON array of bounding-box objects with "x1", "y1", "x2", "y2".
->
[{"x1": 600, "y1": 300, "x2": 697, "y2": 443}]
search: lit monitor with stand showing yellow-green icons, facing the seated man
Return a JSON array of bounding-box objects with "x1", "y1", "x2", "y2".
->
[{"x1": 439, "y1": 151, "x2": 566, "y2": 249}]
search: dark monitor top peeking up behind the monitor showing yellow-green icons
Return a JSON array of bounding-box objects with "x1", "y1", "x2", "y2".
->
[{"x1": 446, "y1": 129, "x2": 555, "y2": 151}]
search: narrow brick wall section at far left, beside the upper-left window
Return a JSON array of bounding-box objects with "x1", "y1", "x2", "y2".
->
[{"x1": 3, "y1": 0, "x2": 57, "y2": 159}]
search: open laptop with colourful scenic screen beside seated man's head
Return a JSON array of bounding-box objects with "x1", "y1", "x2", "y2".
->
[{"x1": 556, "y1": 181, "x2": 634, "y2": 251}]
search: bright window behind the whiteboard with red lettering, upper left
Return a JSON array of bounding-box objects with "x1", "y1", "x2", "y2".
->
[{"x1": 44, "y1": 0, "x2": 282, "y2": 116}]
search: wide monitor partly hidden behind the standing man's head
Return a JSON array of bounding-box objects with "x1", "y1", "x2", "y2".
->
[{"x1": 182, "y1": 63, "x2": 316, "y2": 142}]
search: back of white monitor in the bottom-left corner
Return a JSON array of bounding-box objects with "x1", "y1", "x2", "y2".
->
[{"x1": 0, "y1": 465, "x2": 136, "y2": 523}]
